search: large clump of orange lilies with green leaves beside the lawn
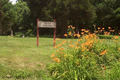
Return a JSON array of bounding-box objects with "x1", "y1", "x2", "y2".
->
[{"x1": 48, "y1": 26, "x2": 120, "y2": 80}]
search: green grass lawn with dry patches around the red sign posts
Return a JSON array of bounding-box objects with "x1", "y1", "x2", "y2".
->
[{"x1": 0, "y1": 36, "x2": 120, "y2": 80}]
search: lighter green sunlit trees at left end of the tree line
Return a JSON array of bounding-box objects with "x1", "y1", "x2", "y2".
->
[{"x1": 0, "y1": 0, "x2": 30, "y2": 35}]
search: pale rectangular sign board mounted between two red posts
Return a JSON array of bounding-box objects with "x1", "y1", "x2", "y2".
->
[{"x1": 38, "y1": 21, "x2": 56, "y2": 28}]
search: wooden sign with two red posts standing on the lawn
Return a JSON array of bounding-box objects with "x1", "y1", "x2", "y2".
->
[{"x1": 37, "y1": 19, "x2": 56, "y2": 46}]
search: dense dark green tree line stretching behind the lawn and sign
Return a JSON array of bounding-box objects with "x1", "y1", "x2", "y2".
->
[{"x1": 0, "y1": 0, "x2": 120, "y2": 37}]
